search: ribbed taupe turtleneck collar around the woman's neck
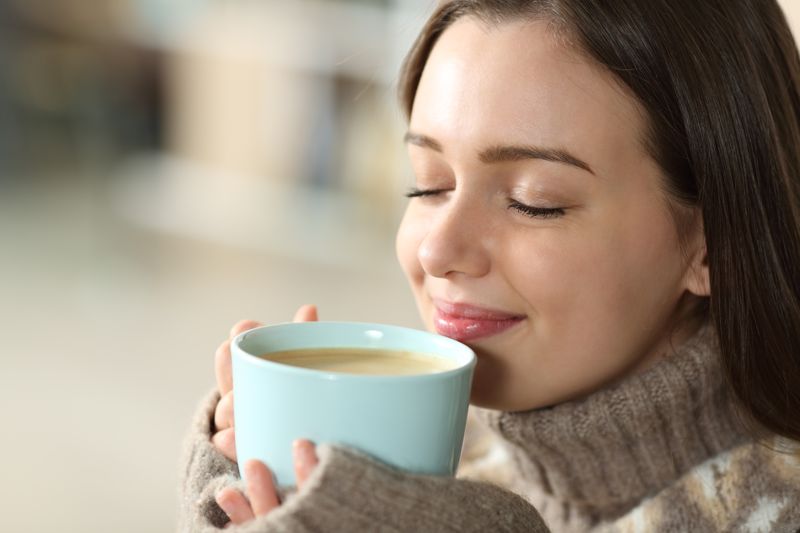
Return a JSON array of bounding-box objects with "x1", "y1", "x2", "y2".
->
[{"x1": 480, "y1": 324, "x2": 745, "y2": 519}]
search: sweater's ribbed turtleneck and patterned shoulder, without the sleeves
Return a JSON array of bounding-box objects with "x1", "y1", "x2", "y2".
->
[{"x1": 471, "y1": 325, "x2": 800, "y2": 532}]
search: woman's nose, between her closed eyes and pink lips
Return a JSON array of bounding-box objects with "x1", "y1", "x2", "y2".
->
[{"x1": 417, "y1": 195, "x2": 491, "y2": 278}]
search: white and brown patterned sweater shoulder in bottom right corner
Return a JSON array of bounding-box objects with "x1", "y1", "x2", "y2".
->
[{"x1": 617, "y1": 441, "x2": 800, "y2": 532}]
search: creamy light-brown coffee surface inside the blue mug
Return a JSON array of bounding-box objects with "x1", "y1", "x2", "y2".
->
[{"x1": 259, "y1": 348, "x2": 456, "y2": 376}]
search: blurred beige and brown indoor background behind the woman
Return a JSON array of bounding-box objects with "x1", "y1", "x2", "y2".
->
[{"x1": 0, "y1": 0, "x2": 800, "y2": 533}]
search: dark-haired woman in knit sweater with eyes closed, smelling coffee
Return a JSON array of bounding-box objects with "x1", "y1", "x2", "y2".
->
[{"x1": 181, "y1": 0, "x2": 800, "y2": 532}]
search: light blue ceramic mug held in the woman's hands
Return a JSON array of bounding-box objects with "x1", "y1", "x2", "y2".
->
[{"x1": 231, "y1": 322, "x2": 475, "y2": 486}]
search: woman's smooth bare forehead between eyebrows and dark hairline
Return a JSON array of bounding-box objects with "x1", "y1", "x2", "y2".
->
[{"x1": 410, "y1": 17, "x2": 645, "y2": 173}]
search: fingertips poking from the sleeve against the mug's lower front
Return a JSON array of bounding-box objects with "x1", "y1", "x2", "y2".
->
[{"x1": 216, "y1": 440, "x2": 319, "y2": 525}]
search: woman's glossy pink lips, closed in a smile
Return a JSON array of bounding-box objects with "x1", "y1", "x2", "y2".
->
[{"x1": 433, "y1": 300, "x2": 525, "y2": 342}]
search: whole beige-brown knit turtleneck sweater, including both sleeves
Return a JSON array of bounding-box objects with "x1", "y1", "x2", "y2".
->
[{"x1": 179, "y1": 327, "x2": 800, "y2": 533}]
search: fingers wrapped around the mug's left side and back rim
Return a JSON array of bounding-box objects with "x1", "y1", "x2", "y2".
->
[{"x1": 211, "y1": 305, "x2": 317, "y2": 461}]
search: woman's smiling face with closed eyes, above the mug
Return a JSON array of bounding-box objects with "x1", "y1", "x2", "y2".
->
[{"x1": 397, "y1": 17, "x2": 708, "y2": 410}]
